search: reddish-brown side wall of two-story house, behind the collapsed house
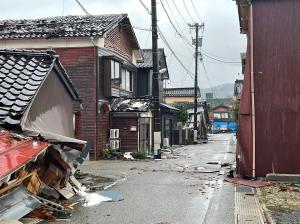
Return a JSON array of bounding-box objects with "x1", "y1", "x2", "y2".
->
[{"x1": 55, "y1": 47, "x2": 97, "y2": 159}]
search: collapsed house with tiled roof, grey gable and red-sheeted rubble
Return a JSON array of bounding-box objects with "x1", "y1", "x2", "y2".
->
[{"x1": 0, "y1": 49, "x2": 89, "y2": 221}]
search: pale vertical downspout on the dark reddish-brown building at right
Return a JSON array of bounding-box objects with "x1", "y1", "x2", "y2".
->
[{"x1": 250, "y1": 4, "x2": 256, "y2": 178}]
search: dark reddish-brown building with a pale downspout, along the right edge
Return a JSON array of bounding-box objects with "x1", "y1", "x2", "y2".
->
[{"x1": 236, "y1": 0, "x2": 300, "y2": 177}]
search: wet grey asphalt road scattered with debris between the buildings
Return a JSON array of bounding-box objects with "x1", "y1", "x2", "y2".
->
[{"x1": 56, "y1": 134, "x2": 234, "y2": 224}]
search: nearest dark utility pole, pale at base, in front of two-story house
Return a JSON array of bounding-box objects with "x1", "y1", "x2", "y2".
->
[{"x1": 151, "y1": 0, "x2": 161, "y2": 155}]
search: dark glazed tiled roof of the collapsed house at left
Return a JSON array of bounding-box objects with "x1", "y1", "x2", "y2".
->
[{"x1": 0, "y1": 49, "x2": 78, "y2": 125}]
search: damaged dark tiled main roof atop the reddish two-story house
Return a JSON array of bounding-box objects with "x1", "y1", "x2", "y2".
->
[{"x1": 0, "y1": 14, "x2": 127, "y2": 39}]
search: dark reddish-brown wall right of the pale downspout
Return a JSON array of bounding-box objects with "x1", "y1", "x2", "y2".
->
[{"x1": 253, "y1": 0, "x2": 300, "y2": 176}]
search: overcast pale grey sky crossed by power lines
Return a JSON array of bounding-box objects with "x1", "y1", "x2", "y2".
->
[{"x1": 0, "y1": 0, "x2": 246, "y2": 88}]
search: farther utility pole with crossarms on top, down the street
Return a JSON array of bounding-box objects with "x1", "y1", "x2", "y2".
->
[{"x1": 189, "y1": 23, "x2": 204, "y2": 143}]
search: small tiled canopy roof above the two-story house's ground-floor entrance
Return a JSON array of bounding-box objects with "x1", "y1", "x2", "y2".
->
[{"x1": 111, "y1": 98, "x2": 151, "y2": 112}]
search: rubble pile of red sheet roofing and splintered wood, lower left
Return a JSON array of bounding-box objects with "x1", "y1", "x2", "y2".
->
[{"x1": 0, "y1": 130, "x2": 86, "y2": 221}]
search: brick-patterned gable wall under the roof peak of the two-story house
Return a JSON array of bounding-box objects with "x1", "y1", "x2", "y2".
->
[{"x1": 104, "y1": 26, "x2": 133, "y2": 60}]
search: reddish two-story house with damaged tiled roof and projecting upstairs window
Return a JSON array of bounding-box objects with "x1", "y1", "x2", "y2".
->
[{"x1": 0, "y1": 14, "x2": 142, "y2": 159}]
